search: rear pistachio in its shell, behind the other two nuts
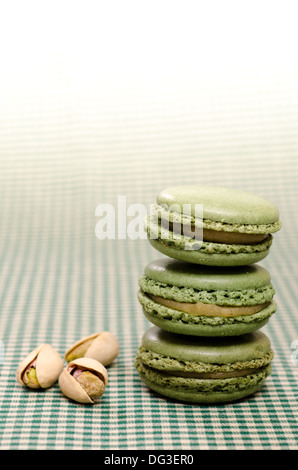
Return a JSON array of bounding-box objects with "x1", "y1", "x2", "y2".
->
[{"x1": 64, "y1": 331, "x2": 119, "y2": 366}]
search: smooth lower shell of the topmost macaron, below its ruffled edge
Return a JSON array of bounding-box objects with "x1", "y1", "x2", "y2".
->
[{"x1": 149, "y1": 238, "x2": 269, "y2": 266}]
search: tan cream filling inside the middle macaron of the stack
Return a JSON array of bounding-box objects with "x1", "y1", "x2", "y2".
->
[{"x1": 147, "y1": 294, "x2": 270, "y2": 317}]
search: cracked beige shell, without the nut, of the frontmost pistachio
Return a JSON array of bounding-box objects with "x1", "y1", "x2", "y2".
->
[{"x1": 59, "y1": 357, "x2": 108, "y2": 403}]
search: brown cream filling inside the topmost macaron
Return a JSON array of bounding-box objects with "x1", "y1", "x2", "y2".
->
[{"x1": 162, "y1": 220, "x2": 268, "y2": 245}]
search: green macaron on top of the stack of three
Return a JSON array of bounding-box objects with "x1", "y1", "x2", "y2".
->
[{"x1": 146, "y1": 185, "x2": 281, "y2": 266}]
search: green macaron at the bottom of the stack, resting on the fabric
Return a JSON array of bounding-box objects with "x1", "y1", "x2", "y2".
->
[{"x1": 135, "y1": 327, "x2": 274, "y2": 404}]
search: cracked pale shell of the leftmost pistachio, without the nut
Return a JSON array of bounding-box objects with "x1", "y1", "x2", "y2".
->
[{"x1": 16, "y1": 343, "x2": 64, "y2": 388}]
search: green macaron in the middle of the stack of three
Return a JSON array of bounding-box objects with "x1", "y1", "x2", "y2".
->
[{"x1": 137, "y1": 257, "x2": 277, "y2": 336}]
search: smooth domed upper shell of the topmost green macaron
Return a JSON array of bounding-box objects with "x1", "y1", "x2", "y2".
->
[{"x1": 157, "y1": 185, "x2": 279, "y2": 225}]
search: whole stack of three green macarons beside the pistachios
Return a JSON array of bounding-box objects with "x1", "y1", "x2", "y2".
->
[{"x1": 135, "y1": 185, "x2": 281, "y2": 403}]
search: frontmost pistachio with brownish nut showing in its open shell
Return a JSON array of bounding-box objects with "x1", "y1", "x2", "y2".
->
[{"x1": 59, "y1": 357, "x2": 108, "y2": 403}]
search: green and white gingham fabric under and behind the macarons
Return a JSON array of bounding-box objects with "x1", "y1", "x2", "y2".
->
[{"x1": 0, "y1": 2, "x2": 298, "y2": 450}]
